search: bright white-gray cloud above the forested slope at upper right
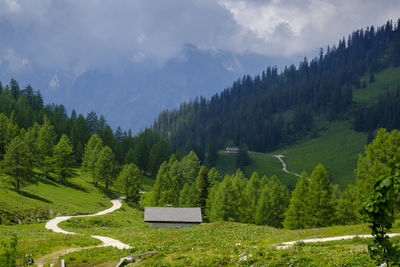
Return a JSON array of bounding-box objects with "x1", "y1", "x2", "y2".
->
[{"x1": 219, "y1": 0, "x2": 400, "y2": 56}]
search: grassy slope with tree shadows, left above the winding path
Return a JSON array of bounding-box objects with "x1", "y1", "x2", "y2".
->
[{"x1": 0, "y1": 172, "x2": 111, "y2": 224}]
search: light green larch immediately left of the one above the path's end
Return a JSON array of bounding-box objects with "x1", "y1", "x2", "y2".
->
[{"x1": 95, "y1": 146, "x2": 117, "y2": 189}]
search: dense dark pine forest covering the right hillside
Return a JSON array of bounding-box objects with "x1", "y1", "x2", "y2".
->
[{"x1": 153, "y1": 20, "x2": 400, "y2": 162}]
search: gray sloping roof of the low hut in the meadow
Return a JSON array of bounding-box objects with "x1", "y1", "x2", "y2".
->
[{"x1": 144, "y1": 207, "x2": 203, "y2": 223}]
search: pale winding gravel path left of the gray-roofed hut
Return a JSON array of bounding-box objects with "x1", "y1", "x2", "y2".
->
[{"x1": 35, "y1": 197, "x2": 131, "y2": 266}]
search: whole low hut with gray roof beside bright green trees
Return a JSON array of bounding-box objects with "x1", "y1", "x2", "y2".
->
[{"x1": 144, "y1": 207, "x2": 203, "y2": 228}]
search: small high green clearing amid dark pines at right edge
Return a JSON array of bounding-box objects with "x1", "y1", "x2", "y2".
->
[{"x1": 353, "y1": 67, "x2": 400, "y2": 104}]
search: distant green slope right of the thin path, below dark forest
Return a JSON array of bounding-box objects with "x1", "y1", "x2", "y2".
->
[{"x1": 274, "y1": 121, "x2": 366, "y2": 188}]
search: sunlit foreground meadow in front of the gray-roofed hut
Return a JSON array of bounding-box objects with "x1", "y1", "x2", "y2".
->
[{"x1": 52, "y1": 205, "x2": 400, "y2": 266}]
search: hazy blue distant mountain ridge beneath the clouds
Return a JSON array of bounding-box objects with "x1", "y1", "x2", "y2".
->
[{"x1": 0, "y1": 44, "x2": 287, "y2": 132}]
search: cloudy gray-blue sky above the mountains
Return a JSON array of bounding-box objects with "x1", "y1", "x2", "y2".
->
[{"x1": 0, "y1": 0, "x2": 400, "y2": 75}]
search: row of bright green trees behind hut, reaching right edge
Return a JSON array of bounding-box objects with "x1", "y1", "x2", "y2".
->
[{"x1": 146, "y1": 129, "x2": 400, "y2": 229}]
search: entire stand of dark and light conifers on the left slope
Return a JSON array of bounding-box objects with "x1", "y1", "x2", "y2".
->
[{"x1": 0, "y1": 79, "x2": 177, "y2": 202}]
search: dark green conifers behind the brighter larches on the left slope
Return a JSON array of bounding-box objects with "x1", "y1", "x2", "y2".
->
[{"x1": 0, "y1": 79, "x2": 172, "y2": 176}]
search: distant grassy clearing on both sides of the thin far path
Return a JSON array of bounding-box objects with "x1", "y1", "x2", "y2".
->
[{"x1": 216, "y1": 121, "x2": 366, "y2": 188}]
